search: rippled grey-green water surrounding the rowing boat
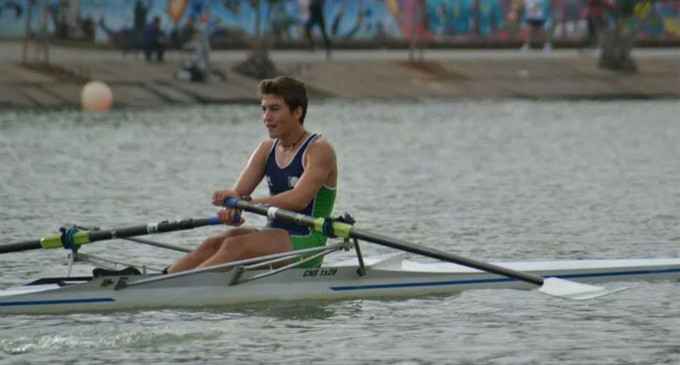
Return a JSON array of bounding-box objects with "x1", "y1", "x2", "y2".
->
[{"x1": 0, "y1": 101, "x2": 680, "y2": 365}]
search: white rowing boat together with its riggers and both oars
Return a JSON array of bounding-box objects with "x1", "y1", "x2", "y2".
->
[{"x1": 0, "y1": 200, "x2": 680, "y2": 314}]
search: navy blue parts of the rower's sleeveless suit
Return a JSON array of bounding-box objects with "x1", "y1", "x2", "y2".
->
[{"x1": 265, "y1": 134, "x2": 335, "y2": 236}]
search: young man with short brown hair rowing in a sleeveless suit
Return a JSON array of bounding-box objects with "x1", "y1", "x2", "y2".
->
[{"x1": 167, "y1": 76, "x2": 338, "y2": 273}]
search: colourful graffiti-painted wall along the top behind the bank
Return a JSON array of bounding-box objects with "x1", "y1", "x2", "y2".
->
[{"x1": 0, "y1": 0, "x2": 680, "y2": 46}]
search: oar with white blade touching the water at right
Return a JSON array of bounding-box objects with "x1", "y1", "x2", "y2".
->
[{"x1": 225, "y1": 198, "x2": 627, "y2": 299}]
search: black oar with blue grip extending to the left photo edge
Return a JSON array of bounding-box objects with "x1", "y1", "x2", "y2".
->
[{"x1": 0, "y1": 217, "x2": 221, "y2": 253}]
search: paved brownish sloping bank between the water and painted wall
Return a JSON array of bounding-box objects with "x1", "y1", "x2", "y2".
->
[{"x1": 0, "y1": 42, "x2": 680, "y2": 108}]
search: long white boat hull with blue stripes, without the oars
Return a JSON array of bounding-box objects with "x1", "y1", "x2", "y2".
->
[{"x1": 0, "y1": 254, "x2": 680, "y2": 314}]
